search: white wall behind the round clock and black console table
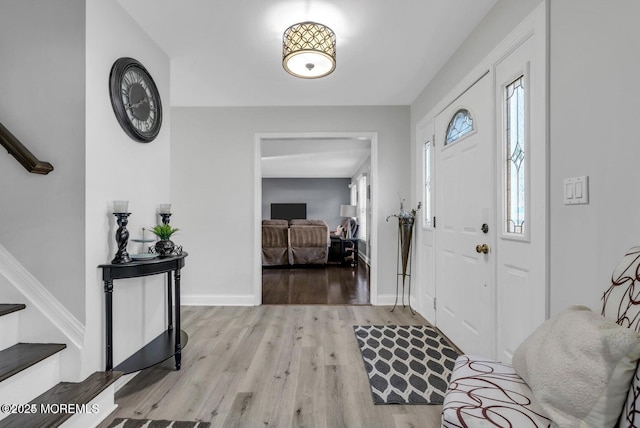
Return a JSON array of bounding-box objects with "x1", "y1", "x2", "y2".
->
[{"x1": 83, "y1": 0, "x2": 171, "y2": 373}]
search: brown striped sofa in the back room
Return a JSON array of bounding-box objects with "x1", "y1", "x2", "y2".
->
[{"x1": 262, "y1": 219, "x2": 330, "y2": 266}]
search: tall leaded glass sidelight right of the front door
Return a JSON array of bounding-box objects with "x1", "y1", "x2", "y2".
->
[{"x1": 505, "y1": 76, "x2": 526, "y2": 234}]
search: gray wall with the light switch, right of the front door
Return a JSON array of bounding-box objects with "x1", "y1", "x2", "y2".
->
[{"x1": 550, "y1": 0, "x2": 640, "y2": 313}]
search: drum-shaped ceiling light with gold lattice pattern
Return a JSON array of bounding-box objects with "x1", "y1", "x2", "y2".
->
[{"x1": 282, "y1": 21, "x2": 336, "y2": 79}]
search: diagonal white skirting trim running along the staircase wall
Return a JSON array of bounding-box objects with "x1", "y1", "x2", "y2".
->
[{"x1": 0, "y1": 245, "x2": 84, "y2": 348}]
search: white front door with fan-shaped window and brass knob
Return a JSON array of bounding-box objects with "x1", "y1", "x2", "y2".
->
[{"x1": 434, "y1": 73, "x2": 496, "y2": 356}]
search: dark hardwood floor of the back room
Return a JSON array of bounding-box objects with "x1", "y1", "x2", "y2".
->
[{"x1": 262, "y1": 261, "x2": 370, "y2": 305}]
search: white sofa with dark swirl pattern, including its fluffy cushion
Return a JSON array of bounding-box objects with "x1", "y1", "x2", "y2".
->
[{"x1": 442, "y1": 247, "x2": 640, "y2": 428}]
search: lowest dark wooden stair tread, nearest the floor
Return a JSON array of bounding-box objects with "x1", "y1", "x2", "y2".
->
[{"x1": 0, "y1": 371, "x2": 122, "y2": 428}]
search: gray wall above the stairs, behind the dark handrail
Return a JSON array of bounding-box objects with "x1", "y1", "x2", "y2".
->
[{"x1": 0, "y1": 0, "x2": 85, "y2": 322}]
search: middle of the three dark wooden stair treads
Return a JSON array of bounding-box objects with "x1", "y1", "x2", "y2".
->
[{"x1": 0, "y1": 343, "x2": 67, "y2": 382}]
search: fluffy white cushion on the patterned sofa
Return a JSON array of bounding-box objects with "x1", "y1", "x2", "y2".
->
[{"x1": 513, "y1": 306, "x2": 640, "y2": 427}]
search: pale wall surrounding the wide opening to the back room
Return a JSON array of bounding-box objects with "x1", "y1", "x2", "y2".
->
[{"x1": 171, "y1": 107, "x2": 410, "y2": 305}]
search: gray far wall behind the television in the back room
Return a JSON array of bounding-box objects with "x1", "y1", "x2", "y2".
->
[{"x1": 262, "y1": 178, "x2": 351, "y2": 229}]
